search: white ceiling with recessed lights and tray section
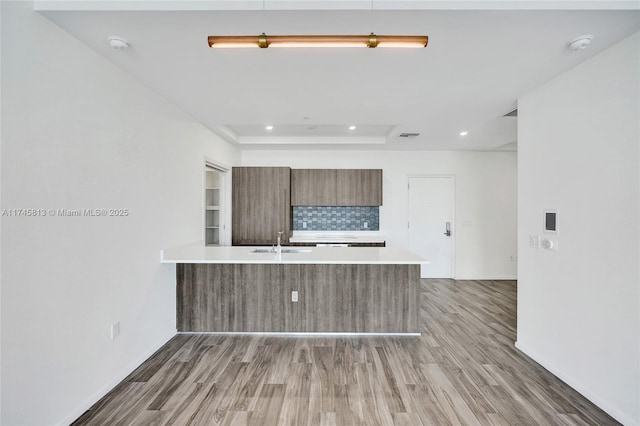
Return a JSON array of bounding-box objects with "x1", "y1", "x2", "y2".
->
[{"x1": 35, "y1": 0, "x2": 640, "y2": 150}]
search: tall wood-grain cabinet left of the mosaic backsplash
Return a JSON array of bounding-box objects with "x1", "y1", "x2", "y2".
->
[{"x1": 231, "y1": 167, "x2": 291, "y2": 245}]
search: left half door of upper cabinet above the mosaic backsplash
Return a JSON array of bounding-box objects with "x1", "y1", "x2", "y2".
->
[{"x1": 291, "y1": 169, "x2": 337, "y2": 206}]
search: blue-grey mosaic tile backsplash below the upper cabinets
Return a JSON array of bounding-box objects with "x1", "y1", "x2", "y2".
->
[{"x1": 293, "y1": 206, "x2": 380, "y2": 231}]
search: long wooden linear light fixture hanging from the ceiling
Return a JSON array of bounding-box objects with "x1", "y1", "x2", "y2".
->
[{"x1": 209, "y1": 33, "x2": 429, "y2": 48}]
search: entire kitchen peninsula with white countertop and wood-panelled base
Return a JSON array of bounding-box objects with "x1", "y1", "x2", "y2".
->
[{"x1": 162, "y1": 242, "x2": 428, "y2": 334}]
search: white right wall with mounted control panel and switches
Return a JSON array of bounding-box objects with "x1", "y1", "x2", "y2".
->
[{"x1": 517, "y1": 34, "x2": 640, "y2": 425}]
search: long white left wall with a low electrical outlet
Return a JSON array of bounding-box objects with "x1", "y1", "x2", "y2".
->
[{"x1": 0, "y1": 2, "x2": 239, "y2": 425}]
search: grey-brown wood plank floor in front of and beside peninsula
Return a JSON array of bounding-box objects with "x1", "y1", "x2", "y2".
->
[{"x1": 73, "y1": 280, "x2": 618, "y2": 426}]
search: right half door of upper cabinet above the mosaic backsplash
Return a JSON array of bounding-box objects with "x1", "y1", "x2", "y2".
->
[{"x1": 336, "y1": 169, "x2": 382, "y2": 206}]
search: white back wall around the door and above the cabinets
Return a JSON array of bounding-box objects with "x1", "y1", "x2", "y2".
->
[{"x1": 242, "y1": 150, "x2": 517, "y2": 279}]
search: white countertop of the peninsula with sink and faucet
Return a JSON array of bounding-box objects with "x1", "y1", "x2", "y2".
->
[{"x1": 161, "y1": 241, "x2": 429, "y2": 265}]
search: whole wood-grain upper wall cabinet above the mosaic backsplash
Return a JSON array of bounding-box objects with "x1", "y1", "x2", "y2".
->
[{"x1": 291, "y1": 169, "x2": 382, "y2": 206}]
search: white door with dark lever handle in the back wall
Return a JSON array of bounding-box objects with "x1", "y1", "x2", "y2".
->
[{"x1": 408, "y1": 176, "x2": 454, "y2": 278}]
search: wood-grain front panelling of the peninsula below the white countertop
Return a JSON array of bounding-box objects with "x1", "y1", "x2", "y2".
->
[{"x1": 177, "y1": 264, "x2": 420, "y2": 333}]
